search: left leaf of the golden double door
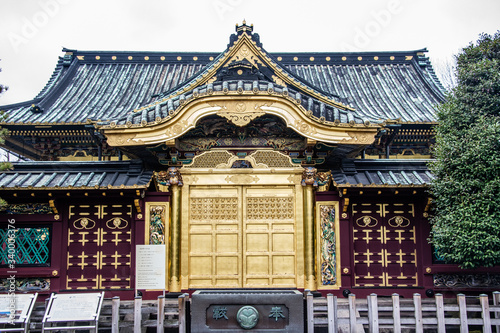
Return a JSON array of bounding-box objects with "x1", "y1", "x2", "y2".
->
[{"x1": 189, "y1": 187, "x2": 242, "y2": 288}]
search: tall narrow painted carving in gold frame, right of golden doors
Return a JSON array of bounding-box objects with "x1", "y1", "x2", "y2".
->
[{"x1": 320, "y1": 205, "x2": 337, "y2": 285}]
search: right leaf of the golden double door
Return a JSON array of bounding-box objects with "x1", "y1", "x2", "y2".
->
[{"x1": 243, "y1": 186, "x2": 296, "y2": 288}]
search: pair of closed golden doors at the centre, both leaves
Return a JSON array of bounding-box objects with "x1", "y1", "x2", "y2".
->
[{"x1": 184, "y1": 185, "x2": 296, "y2": 288}]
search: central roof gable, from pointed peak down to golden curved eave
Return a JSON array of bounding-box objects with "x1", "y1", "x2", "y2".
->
[{"x1": 99, "y1": 26, "x2": 378, "y2": 146}]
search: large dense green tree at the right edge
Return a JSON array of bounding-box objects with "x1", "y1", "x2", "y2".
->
[{"x1": 430, "y1": 31, "x2": 500, "y2": 268}]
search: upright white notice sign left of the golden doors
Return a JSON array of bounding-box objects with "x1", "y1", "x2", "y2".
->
[{"x1": 135, "y1": 245, "x2": 165, "y2": 290}]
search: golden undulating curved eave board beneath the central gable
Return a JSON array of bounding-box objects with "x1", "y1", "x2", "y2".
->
[{"x1": 103, "y1": 95, "x2": 378, "y2": 146}]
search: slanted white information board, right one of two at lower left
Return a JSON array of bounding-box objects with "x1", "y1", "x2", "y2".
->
[{"x1": 46, "y1": 293, "x2": 103, "y2": 322}]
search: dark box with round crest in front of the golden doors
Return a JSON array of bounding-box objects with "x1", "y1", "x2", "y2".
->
[{"x1": 191, "y1": 290, "x2": 304, "y2": 332}]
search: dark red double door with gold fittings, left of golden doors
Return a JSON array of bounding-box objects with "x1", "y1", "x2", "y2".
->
[{"x1": 66, "y1": 205, "x2": 132, "y2": 289}]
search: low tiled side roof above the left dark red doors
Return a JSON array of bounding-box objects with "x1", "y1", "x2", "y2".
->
[{"x1": 0, "y1": 160, "x2": 153, "y2": 190}]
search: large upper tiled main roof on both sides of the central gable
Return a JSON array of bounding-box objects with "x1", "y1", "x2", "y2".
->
[{"x1": 0, "y1": 33, "x2": 444, "y2": 124}]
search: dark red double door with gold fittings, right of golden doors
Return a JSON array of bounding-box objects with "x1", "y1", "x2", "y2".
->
[{"x1": 352, "y1": 203, "x2": 418, "y2": 287}]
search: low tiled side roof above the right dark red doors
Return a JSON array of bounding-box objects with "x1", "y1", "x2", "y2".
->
[{"x1": 332, "y1": 159, "x2": 434, "y2": 187}]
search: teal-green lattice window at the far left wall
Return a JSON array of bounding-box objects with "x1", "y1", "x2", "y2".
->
[{"x1": 0, "y1": 228, "x2": 50, "y2": 266}]
